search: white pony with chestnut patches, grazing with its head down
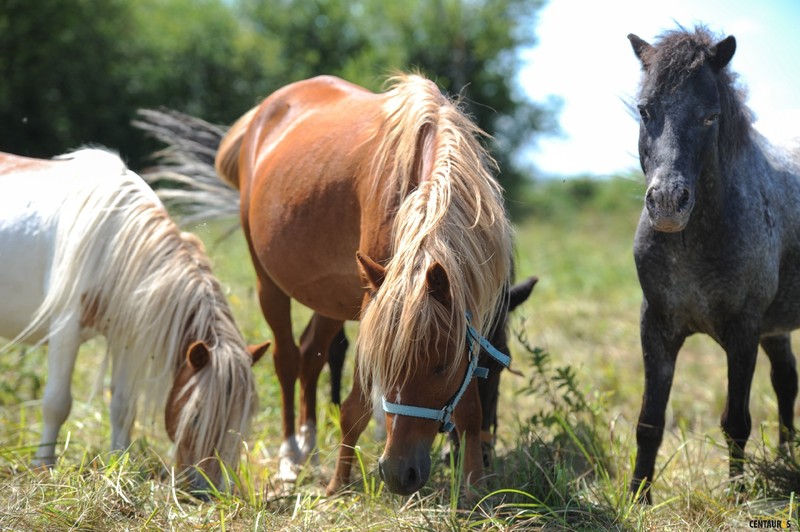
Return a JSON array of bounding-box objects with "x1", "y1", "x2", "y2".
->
[{"x1": 0, "y1": 149, "x2": 267, "y2": 489}]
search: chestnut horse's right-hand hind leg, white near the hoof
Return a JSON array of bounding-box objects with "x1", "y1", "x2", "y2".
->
[{"x1": 297, "y1": 313, "x2": 342, "y2": 461}]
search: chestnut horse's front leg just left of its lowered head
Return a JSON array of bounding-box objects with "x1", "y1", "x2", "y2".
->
[{"x1": 326, "y1": 364, "x2": 371, "y2": 495}]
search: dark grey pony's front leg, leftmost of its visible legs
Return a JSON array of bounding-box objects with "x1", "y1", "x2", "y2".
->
[{"x1": 631, "y1": 301, "x2": 686, "y2": 504}]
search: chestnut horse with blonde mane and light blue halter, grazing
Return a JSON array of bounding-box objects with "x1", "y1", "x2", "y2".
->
[{"x1": 138, "y1": 75, "x2": 511, "y2": 494}]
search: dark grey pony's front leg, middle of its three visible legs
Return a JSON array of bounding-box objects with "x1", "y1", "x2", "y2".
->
[{"x1": 720, "y1": 320, "x2": 759, "y2": 489}]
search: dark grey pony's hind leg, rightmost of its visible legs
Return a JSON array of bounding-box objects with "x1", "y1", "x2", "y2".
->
[{"x1": 761, "y1": 334, "x2": 797, "y2": 452}]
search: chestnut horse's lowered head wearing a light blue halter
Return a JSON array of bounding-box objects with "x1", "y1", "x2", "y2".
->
[{"x1": 358, "y1": 254, "x2": 494, "y2": 495}]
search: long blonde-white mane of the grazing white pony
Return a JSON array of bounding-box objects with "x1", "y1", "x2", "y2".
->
[{"x1": 17, "y1": 150, "x2": 257, "y2": 481}]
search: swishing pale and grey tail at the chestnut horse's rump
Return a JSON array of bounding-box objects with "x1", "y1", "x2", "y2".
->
[{"x1": 133, "y1": 109, "x2": 244, "y2": 225}]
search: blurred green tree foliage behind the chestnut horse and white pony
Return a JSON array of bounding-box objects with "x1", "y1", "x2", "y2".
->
[{"x1": 0, "y1": 0, "x2": 552, "y2": 188}]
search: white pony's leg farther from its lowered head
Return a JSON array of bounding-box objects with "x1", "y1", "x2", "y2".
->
[{"x1": 33, "y1": 320, "x2": 81, "y2": 467}]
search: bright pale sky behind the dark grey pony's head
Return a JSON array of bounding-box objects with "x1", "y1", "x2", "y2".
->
[{"x1": 519, "y1": 0, "x2": 800, "y2": 177}]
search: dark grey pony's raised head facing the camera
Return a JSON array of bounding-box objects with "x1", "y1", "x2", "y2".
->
[{"x1": 628, "y1": 30, "x2": 736, "y2": 232}]
